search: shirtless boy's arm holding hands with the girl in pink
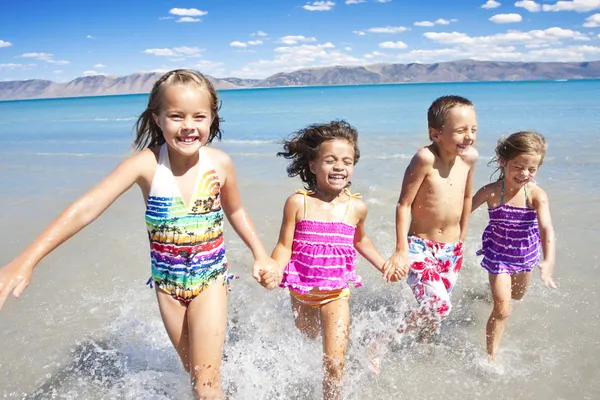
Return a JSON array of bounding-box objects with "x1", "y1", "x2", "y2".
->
[{"x1": 383, "y1": 148, "x2": 434, "y2": 280}]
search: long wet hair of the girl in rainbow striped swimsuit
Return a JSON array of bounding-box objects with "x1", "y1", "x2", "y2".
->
[{"x1": 133, "y1": 69, "x2": 222, "y2": 150}]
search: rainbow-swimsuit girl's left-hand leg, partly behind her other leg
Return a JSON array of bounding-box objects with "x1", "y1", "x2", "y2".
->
[{"x1": 156, "y1": 287, "x2": 190, "y2": 372}]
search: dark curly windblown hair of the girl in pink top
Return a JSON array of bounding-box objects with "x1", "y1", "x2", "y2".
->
[{"x1": 277, "y1": 120, "x2": 360, "y2": 191}]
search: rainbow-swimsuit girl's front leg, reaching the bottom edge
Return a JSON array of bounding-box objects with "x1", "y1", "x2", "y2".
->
[{"x1": 187, "y1": 282, "x2": 227, "y2": 400}]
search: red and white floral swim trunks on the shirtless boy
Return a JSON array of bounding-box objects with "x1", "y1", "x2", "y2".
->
[{"x1": 407, "y1": 235, "x2": 463, "y2": 322}]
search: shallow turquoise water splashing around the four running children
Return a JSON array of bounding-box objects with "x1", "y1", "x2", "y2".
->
[{"x1": 0, "y1": 81, "x2": 600, "y2": 399}]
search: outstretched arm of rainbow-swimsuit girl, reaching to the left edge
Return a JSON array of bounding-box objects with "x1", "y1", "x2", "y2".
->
[{"x1": 0, "y1": 150, "x2": 156, "y2": 309}]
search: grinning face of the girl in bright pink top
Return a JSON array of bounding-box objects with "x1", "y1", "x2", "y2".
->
[{"x1": 310, "y1": 139, "x2": 355, "y2": 192}]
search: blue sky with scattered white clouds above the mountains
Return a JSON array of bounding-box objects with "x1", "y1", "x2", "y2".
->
[{"x1": 0, "y1": 0, "x2": 600, "y2": 82}]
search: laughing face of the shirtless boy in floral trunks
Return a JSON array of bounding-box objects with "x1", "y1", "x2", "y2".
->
[{"x1": 430, "y1": 106, "x2": 477, "y2": 156}]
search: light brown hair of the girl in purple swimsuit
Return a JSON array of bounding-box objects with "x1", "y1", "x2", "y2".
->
[{"x1": 489, "y1": 131, "x2": 548, "y2": 179}]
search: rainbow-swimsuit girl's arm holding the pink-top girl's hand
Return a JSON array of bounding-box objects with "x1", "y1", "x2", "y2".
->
[{"x1": 213, "y1": 150, "x2": 278, "y2": 289}]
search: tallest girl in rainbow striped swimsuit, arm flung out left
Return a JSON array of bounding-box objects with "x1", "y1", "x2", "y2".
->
[{"x1": 0, "y1": 70, "x2": 279, "y2": 399}]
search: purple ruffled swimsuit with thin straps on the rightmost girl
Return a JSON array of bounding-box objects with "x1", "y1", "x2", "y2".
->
[{"x1": 477, "y1": 181, "x2": 541, "y2": 275}]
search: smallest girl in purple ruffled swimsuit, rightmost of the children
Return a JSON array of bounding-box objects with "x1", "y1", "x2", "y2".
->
[{"x1": 471, "y1": 132, "x2": 556, "y2": 360}]
